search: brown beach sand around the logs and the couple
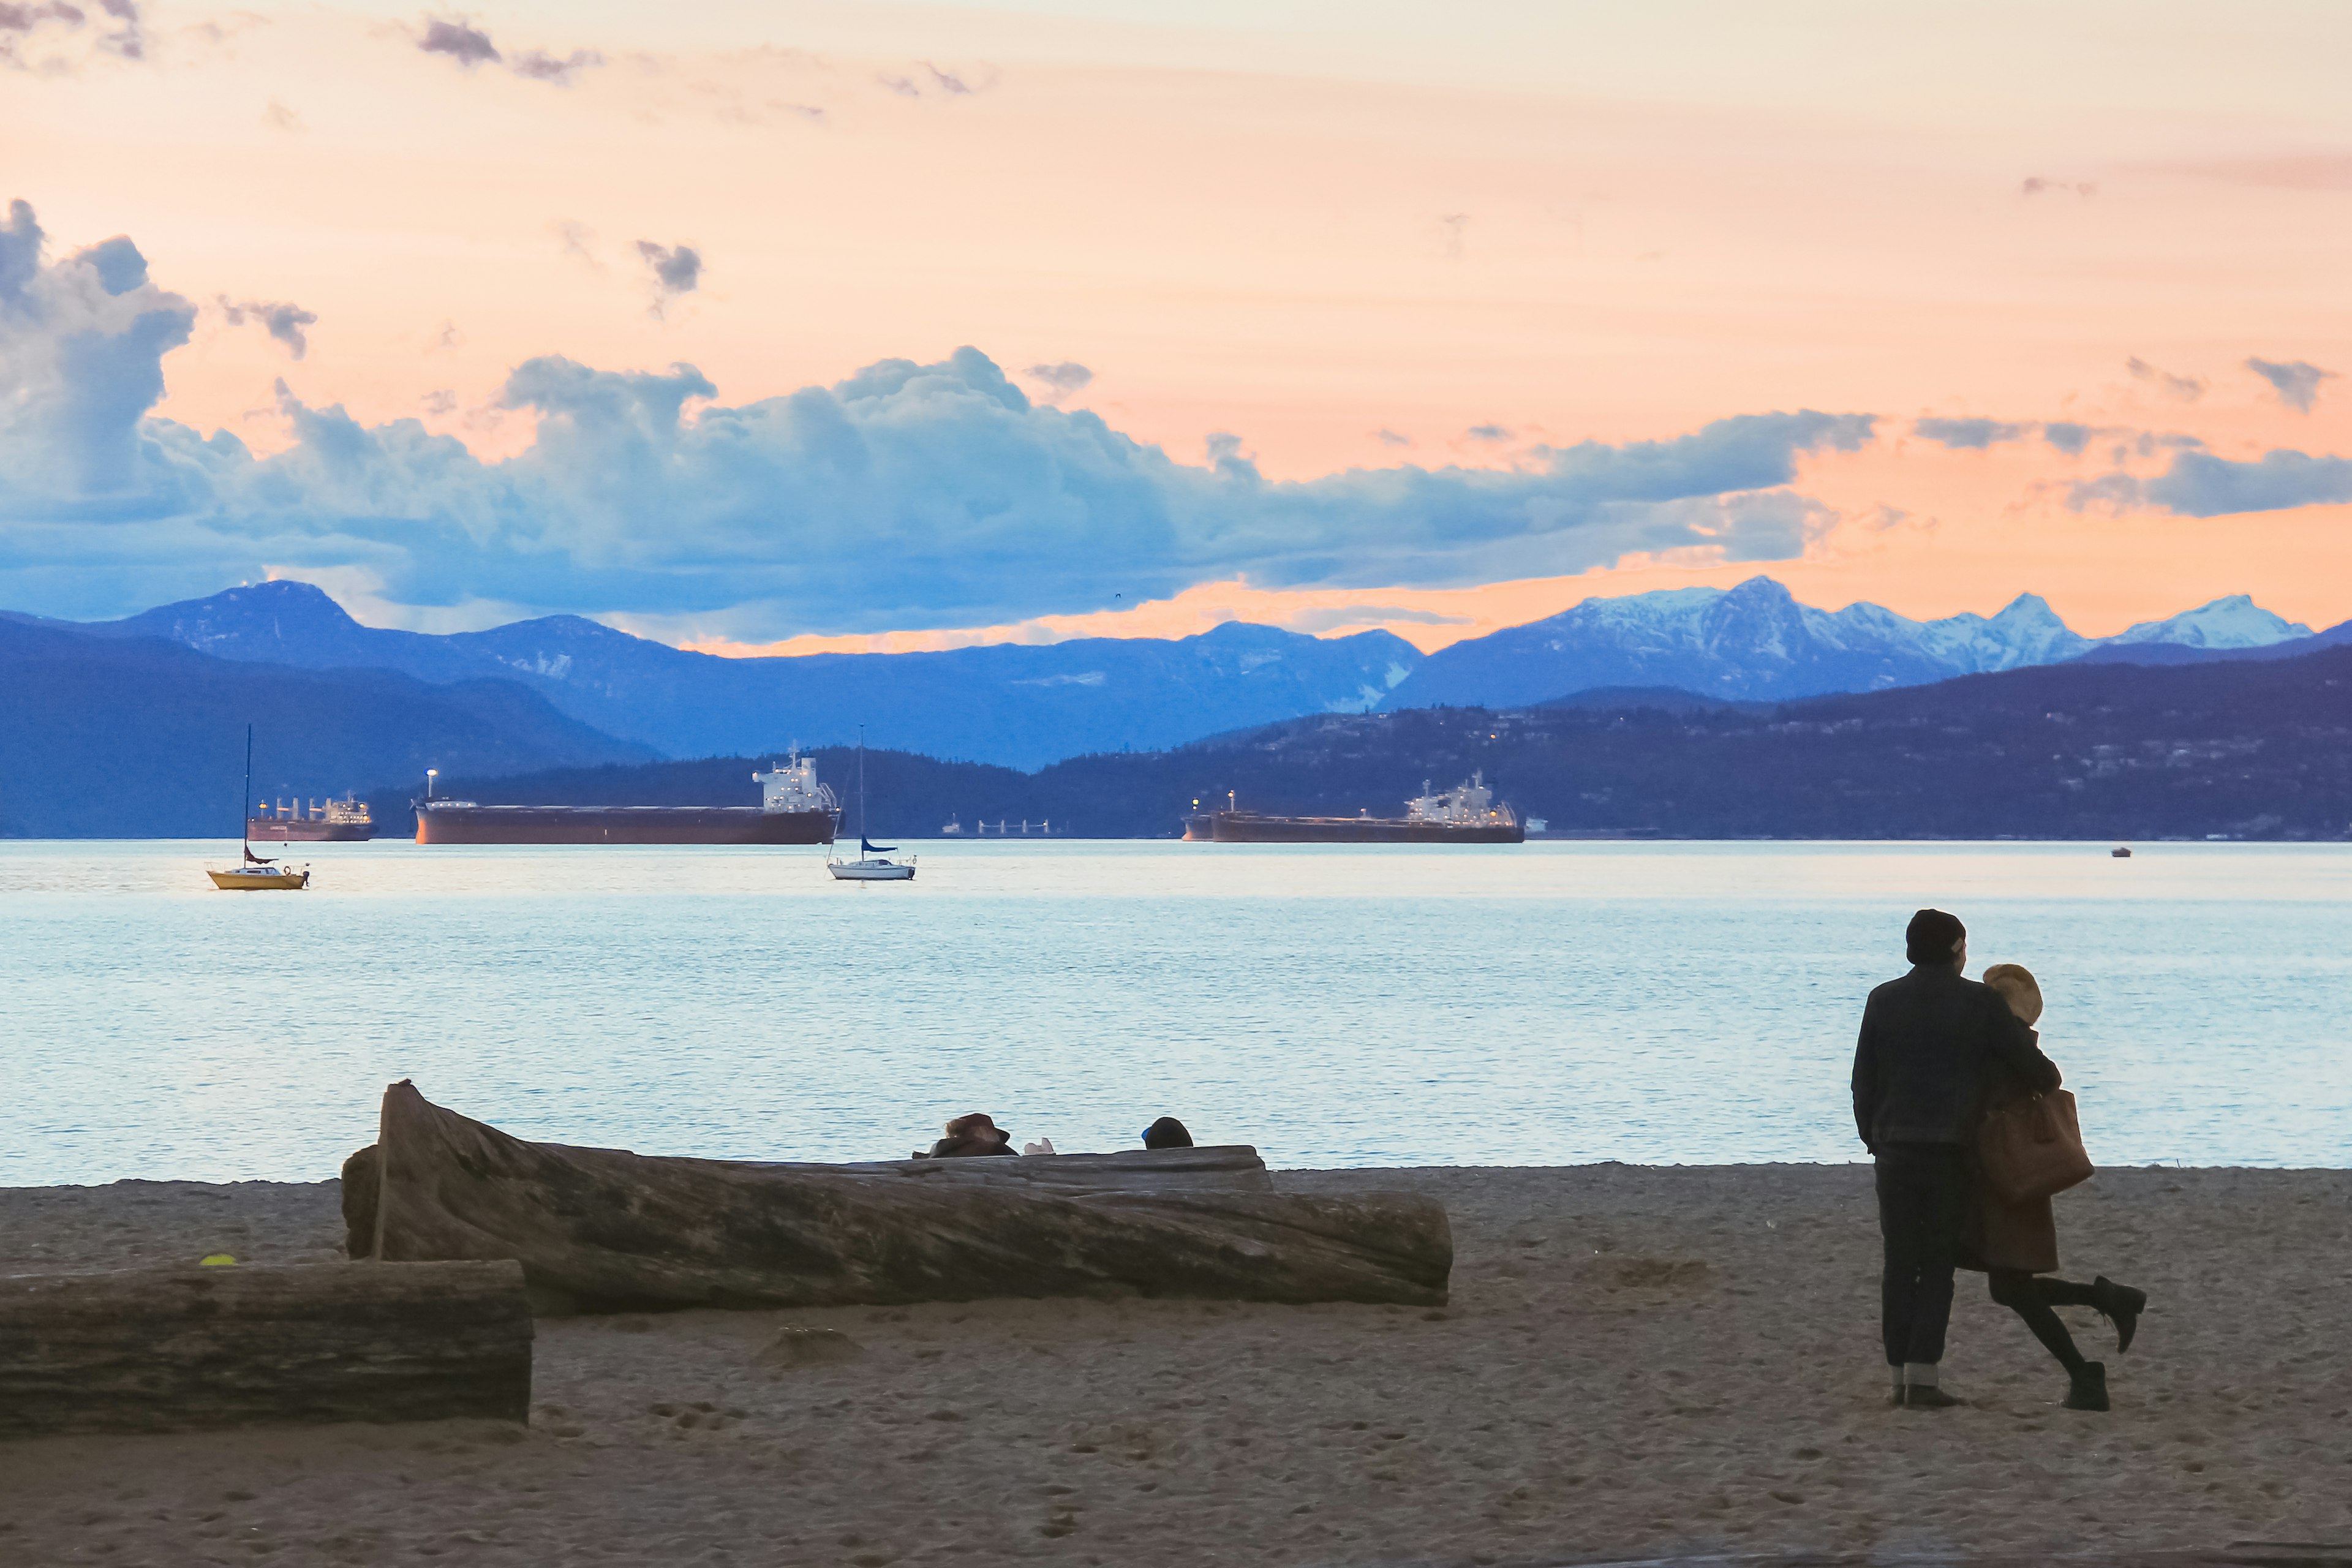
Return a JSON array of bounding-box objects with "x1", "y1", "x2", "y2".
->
[{"x1": 0, "y1": 1166, "x2": 2352, "y2": 1568}]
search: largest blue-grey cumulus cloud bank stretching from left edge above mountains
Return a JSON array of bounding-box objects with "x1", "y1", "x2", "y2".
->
[{"x1": 0, "y1": 200, "x2": 1872, "y2": 642}]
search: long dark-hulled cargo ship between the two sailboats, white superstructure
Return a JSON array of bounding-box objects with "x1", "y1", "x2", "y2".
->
[{"x1": 412, "y1": 750, "x2": 842, "y2": 844}]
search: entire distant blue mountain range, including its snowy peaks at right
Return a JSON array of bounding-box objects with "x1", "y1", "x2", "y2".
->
[{"x1": 14, "y1": 576, "x2": 2352, "y2": 783}]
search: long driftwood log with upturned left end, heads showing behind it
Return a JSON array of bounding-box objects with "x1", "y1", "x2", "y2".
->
[{"x1": 344, "y1": 1082, "x2": 1453, "y2": 1312}]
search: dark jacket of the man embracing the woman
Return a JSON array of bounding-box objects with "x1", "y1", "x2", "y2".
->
[{"x1": 1853, "y1": 964, "x2": 2058, "y2": 1152}]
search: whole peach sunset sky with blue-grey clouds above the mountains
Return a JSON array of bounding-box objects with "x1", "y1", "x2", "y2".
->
[{"x1": 0, "y1": 0, "x2": 2352, "y2": 651}]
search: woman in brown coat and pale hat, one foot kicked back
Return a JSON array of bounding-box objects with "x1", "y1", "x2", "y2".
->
[{"x1": 1962, "y1": 964, "x2": 2147, "y2": 1411}]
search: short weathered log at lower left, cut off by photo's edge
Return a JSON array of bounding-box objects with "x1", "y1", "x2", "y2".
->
[{"x1": 0, "y1": 1262, "x2": 532, "y2": 1436}]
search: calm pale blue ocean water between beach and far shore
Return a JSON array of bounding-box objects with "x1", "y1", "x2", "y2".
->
[{"x1": 0, "y1": 842, "x2": 2352, "y2": 1185}]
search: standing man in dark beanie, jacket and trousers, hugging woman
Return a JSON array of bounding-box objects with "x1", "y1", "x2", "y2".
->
[{"x1": 1853, "y1": 910, "x2": 2058, "y2": 1411}]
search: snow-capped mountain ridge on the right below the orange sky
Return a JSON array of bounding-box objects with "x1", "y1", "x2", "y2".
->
[{"x1": 1383, "y1": 576, "x2": 2310, "y2": 707}]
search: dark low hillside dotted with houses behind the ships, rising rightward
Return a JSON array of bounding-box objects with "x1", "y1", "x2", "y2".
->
[{"x1": 404, "y1": 646, "x2": 2352, "y2": 842}]
